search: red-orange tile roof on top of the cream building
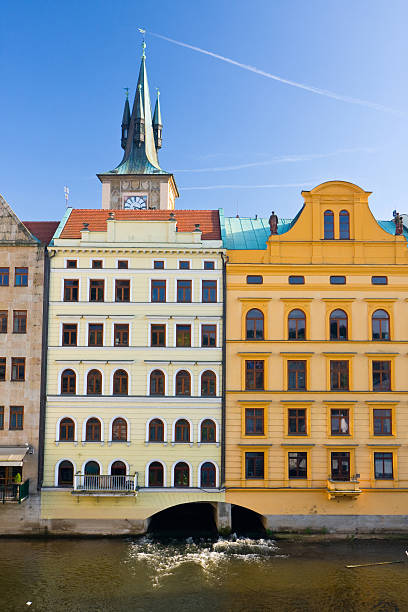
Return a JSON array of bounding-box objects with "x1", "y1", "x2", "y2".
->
[{"x1": 60, "y1": 208, "x2": 221, "y2": 240}]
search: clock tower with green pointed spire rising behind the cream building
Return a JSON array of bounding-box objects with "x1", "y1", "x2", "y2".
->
[{"x1": 97, "y1": 41, "x2": 179, "y2": 210}]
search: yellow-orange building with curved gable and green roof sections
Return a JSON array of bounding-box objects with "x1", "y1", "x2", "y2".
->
[{"x1": 221, "y1": 181, "x2": 408, "y2": 531}]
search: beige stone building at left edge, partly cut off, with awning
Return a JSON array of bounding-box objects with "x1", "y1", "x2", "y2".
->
[{"x1": 0, "y1": 197, "x2": 57, "y2": 533}]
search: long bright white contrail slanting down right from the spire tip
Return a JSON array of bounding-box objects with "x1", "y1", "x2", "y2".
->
[{"x1": 148, "y1": 30, "x2": 405, "y2": 116}]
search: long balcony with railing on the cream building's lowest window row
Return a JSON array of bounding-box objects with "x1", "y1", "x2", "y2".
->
[{"x1": 72, "y1": 472, "x2": 138, "y2": 497}]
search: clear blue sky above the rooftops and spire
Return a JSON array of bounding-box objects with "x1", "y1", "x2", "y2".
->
[{"x1": 0, "y1": 0, "x2": 408, "y2": 220}]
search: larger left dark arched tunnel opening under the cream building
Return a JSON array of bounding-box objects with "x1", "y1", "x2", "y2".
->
[{"x1": 148, "y1": 502, "x2": 218, "y2": 538}]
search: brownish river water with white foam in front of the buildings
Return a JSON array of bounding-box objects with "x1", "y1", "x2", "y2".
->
[{"x1": 0, "y1": 536, "x2": 408, "y2": 612}]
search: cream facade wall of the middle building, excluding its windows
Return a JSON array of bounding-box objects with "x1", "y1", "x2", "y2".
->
[{"x1": 42, "y1": 220, "x2": 224, "y2": 530}]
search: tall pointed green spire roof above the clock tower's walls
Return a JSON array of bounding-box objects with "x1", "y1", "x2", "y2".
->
[{"x1": 107, "y1": 42, "x2": 169, "y2": 174}]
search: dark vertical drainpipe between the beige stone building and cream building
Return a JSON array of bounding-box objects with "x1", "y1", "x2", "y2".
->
[{"x1": 37, "y1": 247, "x2": 57, "y2": 491}]
